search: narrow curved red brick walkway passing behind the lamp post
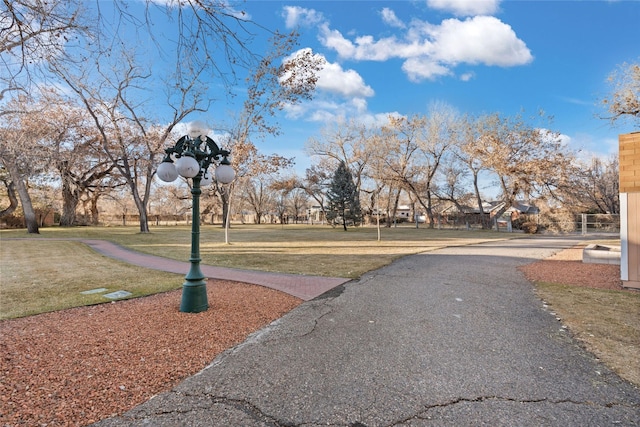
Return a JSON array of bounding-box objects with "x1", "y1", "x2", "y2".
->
[{"x1": 81, "y1": 239, "x2": 351, "y2": 301}]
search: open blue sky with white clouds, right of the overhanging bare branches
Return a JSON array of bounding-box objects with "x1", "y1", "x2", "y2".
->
[{"x1": 205, "y1": 0, "x2": 640, "y2": 174}]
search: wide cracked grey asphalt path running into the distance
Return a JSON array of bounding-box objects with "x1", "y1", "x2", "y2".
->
[{"x1": 95, "y1": 237, "x2": 640, "y2": 427}]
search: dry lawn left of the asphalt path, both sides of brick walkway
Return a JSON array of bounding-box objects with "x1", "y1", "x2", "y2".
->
[{"x1": 0, "y1": 225, "x2": 514, "y2": 319}]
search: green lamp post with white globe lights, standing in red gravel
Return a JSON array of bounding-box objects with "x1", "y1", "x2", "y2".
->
[{"x1": 156, "y1": 126, "x2": 235, "y2": 313}]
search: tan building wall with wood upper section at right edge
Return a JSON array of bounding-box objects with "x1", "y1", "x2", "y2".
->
[{"x1": 619, "y1": 132, "x2": 640, "y2": 288}]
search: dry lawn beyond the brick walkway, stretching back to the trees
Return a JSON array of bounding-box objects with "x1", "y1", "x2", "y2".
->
[{"x1": 0, "y1": 225, "x2": 510, "y2": 278}]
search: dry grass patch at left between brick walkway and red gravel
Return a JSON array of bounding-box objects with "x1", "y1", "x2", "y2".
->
[{"x1": 0, "y1": 238, "x2": 184, "y2": 319}]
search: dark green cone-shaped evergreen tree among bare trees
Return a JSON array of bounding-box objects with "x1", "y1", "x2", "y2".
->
[{"x1": 327, "y1": 162, "x2": 362, "y2": 231}]
